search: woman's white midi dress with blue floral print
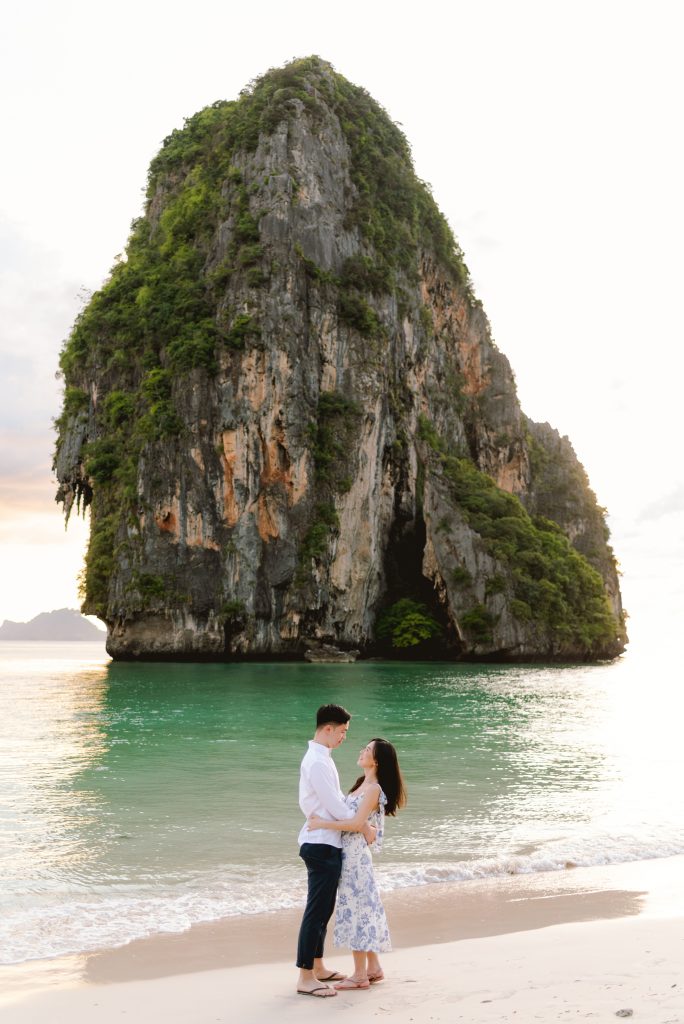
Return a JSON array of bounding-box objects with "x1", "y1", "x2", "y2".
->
[{"x1": 333, "y1": 790, "x2": 392, "y2": 953}]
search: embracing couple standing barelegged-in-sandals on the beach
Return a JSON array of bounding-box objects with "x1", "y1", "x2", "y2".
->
[{"x1": 297, "y1": 705, "x2": 407, "y2": 998}]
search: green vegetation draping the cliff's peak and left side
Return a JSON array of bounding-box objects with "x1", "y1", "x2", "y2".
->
[{"x1": 56, "y1": 57, "x2": 469, "y2": 616}]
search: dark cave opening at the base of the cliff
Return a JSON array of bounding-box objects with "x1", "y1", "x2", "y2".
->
[{"x1": 375, "y1": 513, "x2": 459, "y2": 660}]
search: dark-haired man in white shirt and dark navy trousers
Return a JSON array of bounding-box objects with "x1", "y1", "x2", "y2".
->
[{"x1": 297, "y1": 705, "x2": 375, "y2": 998}]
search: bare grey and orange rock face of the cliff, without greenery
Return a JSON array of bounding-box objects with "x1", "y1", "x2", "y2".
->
[{"x1": 55, "y1": 59, "x2": 624, "y2": 659}]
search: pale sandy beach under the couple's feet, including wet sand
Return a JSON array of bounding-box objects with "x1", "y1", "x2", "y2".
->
[{"x1": 0, "y1": 857, "x2": 684, "y2": 1024}]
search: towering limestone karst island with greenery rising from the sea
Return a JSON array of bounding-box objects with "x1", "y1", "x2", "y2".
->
[{"x1": 55, "y1": 57, "x2": 626, "y2": 659}]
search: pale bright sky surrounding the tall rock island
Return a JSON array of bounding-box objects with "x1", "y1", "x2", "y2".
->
[{"x1": 0, "y1": 0, "x2": 684, "y2": 651}]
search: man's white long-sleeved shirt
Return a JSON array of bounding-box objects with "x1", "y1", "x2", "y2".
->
[{"x1": 299, "y1": 739, "x2": 354, "y2": 847}]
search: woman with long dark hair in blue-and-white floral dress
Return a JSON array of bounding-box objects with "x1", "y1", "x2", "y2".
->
[{"x1": 309, "y1": 737, "x2": 407, "y2": 989}]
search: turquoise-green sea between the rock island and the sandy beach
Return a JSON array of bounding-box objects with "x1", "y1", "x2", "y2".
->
[{"x1": 0, "y1": 643, "x2": 684, "y2": 964}]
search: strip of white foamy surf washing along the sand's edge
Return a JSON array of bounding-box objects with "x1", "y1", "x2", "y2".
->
[{"x1": 0, "y1": 829, "x2": 684, "y2": 964}]
